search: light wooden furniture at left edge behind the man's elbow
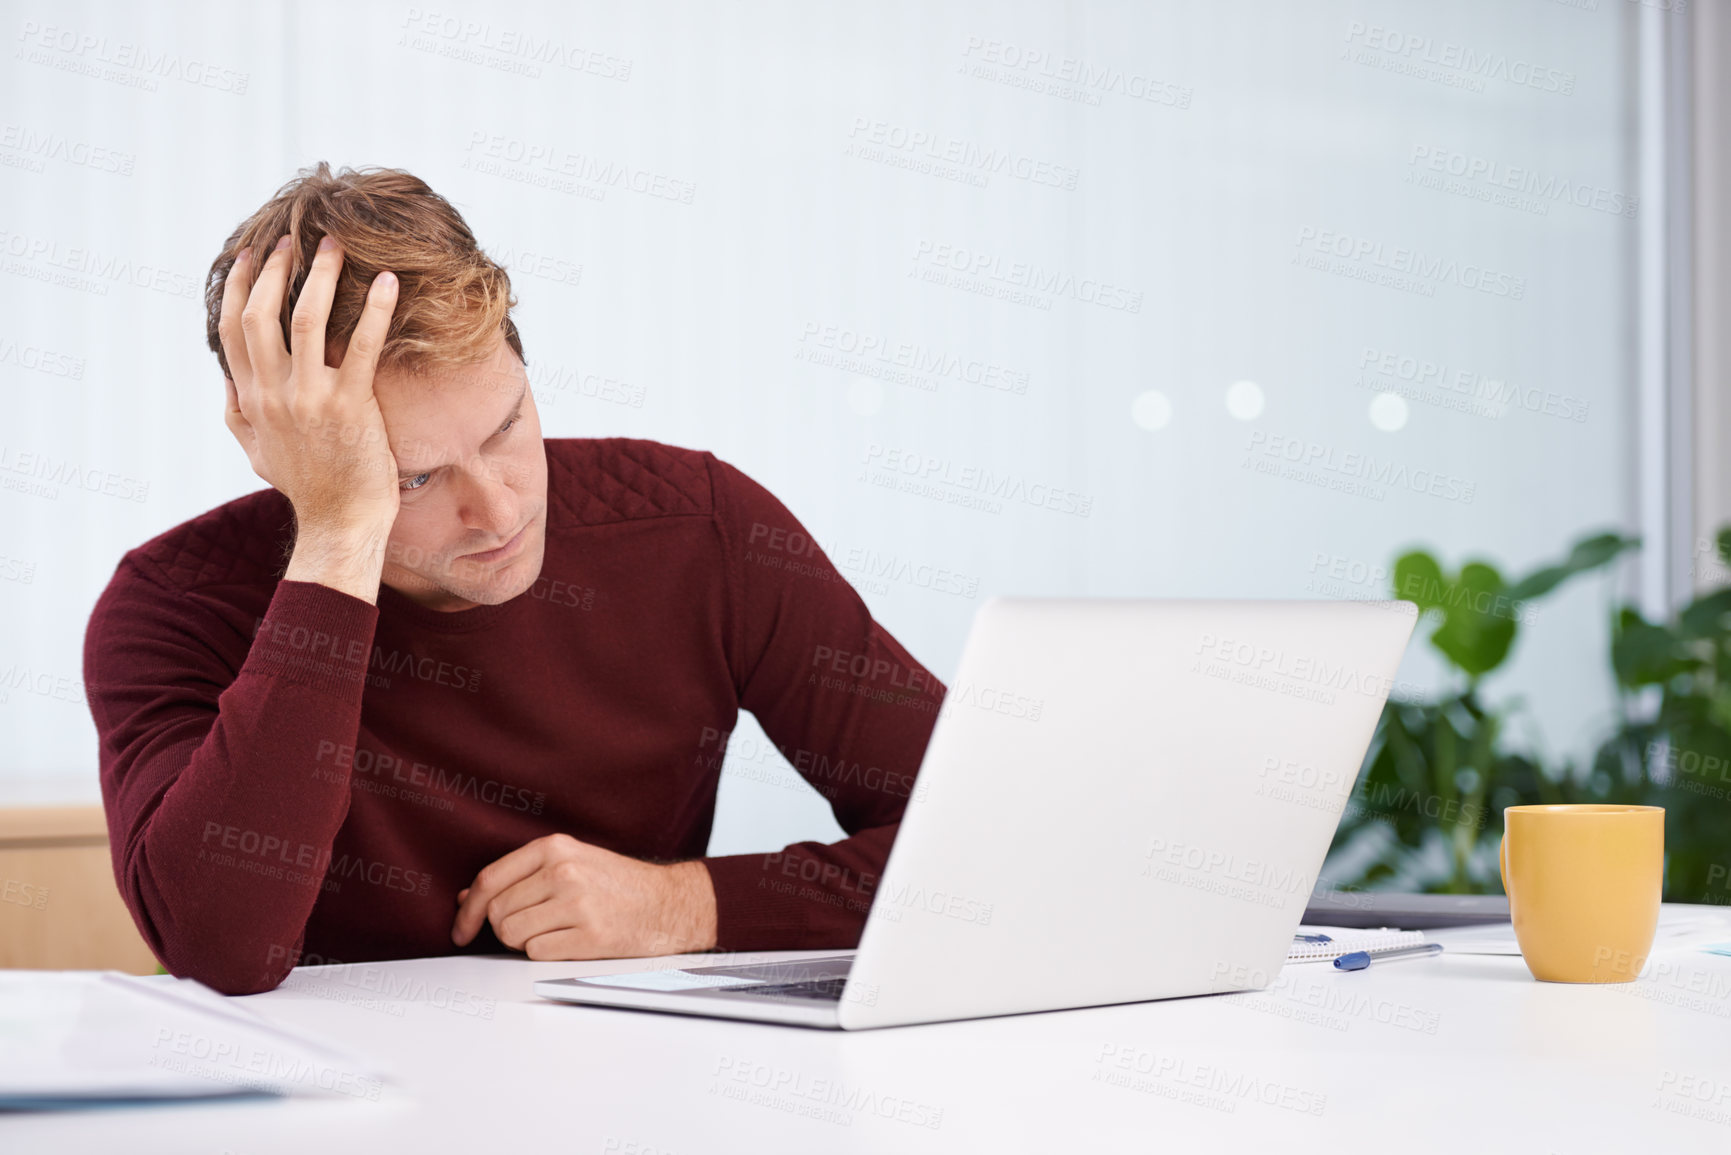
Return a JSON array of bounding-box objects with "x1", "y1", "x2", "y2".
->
[{"x1": 0, "y1": 805, "x2": 158, "y2": 975}]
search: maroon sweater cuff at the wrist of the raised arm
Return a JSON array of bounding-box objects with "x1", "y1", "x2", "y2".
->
[{"x1": 241, "y1": 580, "x2": 379, "y2": 698}]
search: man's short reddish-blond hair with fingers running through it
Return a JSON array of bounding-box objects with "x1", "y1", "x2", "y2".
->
[{"x1": 204, "y1": 161, "x2": 528, "y2": 377}]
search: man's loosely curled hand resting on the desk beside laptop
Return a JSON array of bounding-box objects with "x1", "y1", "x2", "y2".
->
[{"x1": 450, "y1": 835, "x2": 715, "y2": 959}]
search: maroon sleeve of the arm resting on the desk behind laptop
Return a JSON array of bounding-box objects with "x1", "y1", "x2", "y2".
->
[{"x1": 703, "y1": 457, "x2": 943, "y2": 951}]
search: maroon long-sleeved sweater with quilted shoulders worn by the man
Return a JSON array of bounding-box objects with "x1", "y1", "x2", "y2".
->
[{"x1": 85, "y1": 438, "x2": 943, "y2": 994}]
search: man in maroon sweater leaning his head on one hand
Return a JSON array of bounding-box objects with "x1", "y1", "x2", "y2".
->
[{"x1": 85, "y1": 165, "x2": 943, "y2": 994}]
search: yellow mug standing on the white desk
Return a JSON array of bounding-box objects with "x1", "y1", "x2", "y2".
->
[{"x1": 1503, "y1": 803, "x2": 1665, "y2": 982}]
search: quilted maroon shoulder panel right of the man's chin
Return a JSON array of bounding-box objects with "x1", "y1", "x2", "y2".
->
[{"x1": 547, "y1": 436, "x2": 715, "y2": 525}]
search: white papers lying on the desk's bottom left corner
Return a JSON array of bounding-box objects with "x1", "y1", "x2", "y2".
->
[{"x1": 0, "y1": 971, "x2": 384, "y2": 1107}]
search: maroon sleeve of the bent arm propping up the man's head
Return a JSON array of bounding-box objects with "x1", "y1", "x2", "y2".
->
[{"x1": 85, "y1": 559, "x2": 377, "y2": 994}]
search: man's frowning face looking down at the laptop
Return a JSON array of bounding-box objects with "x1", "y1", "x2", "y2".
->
[{"x1": 372, "y1": 336, "x2": 547, "y2": 611}]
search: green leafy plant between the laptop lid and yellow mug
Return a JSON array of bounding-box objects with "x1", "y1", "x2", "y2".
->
[{"x1": 1324, "y1": 533, "x2": 1640, "y2": 894}]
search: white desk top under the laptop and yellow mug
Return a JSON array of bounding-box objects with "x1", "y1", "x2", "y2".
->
[{"x1": 10, "y1": 919, "x2": 1731, "y2": 1155}]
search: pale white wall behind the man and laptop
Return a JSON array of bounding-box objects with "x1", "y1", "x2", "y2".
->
[{"x1": 0, "y1": 0, "x2": 1636, "y2": 852}]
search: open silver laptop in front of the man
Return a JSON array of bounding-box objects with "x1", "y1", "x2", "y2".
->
[{"x1": 535, "y1": 597, "x2": 1418, "y2": 1030}]
